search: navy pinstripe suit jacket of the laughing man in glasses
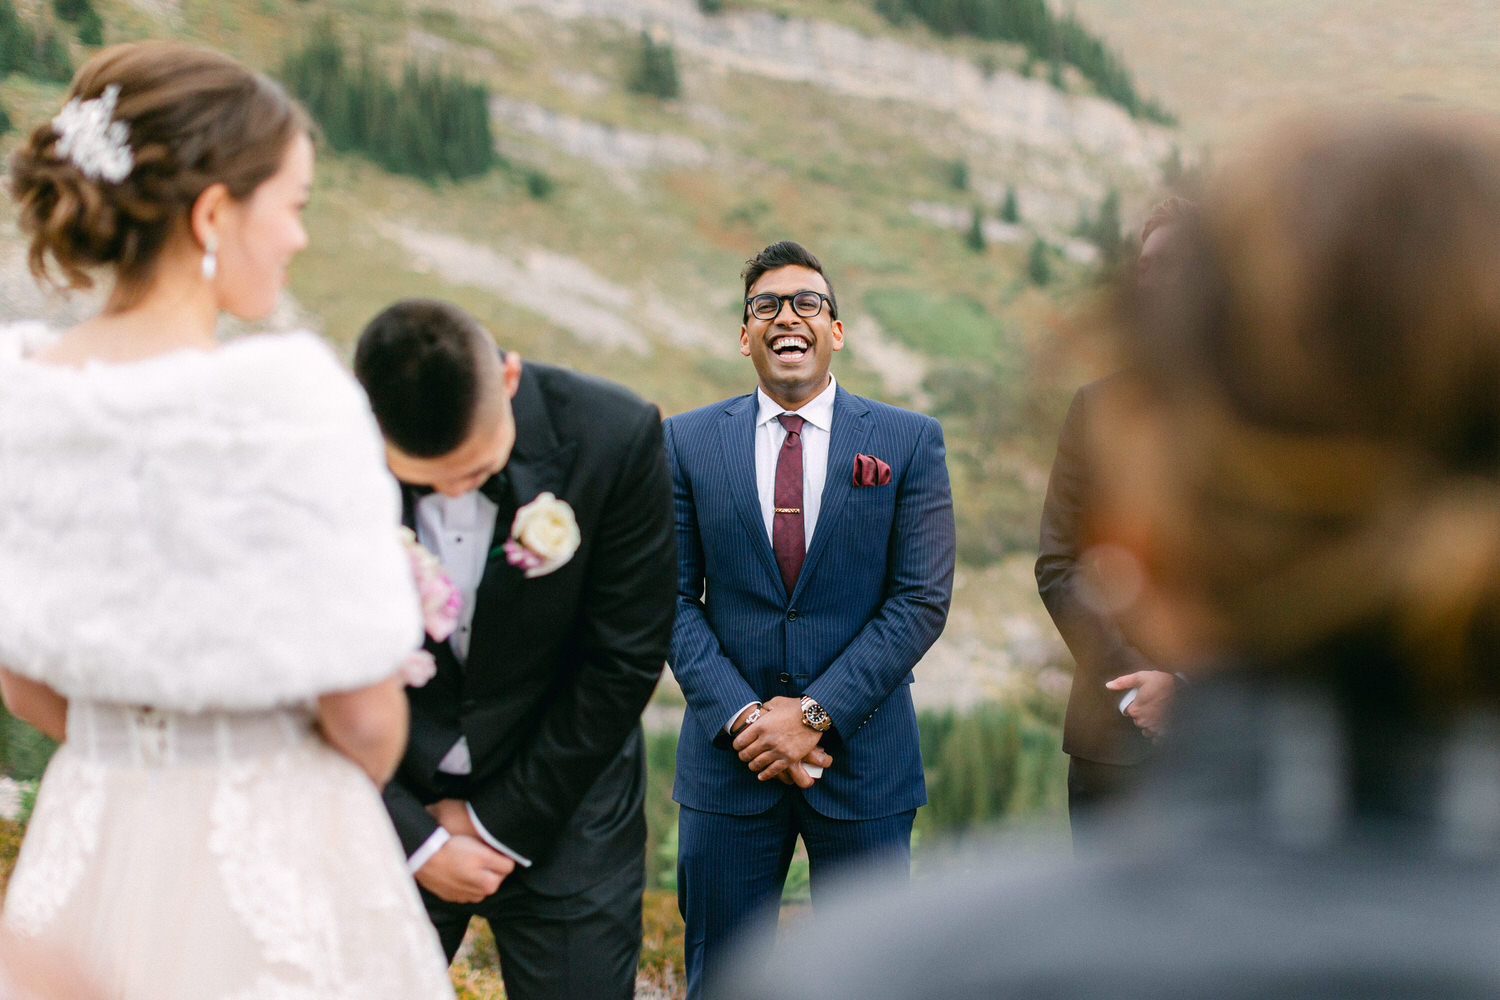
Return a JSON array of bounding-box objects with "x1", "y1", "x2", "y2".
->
[{"x1": 663, "y1": 387, "x2": 954, "y2": 819}]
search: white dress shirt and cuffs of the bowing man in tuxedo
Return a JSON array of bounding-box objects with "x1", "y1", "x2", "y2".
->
[{"x1": 407, "y1": 490, "x2": 531, "y2": 873}]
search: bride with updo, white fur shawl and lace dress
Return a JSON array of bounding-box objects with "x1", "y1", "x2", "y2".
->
[{"x1": 0, "y1": 42, "x2": 453, "y2": 1000}]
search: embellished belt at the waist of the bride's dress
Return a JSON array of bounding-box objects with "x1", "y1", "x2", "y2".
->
[{"x1": 68, "y1": 700, "x2": 314, "y2": 768}]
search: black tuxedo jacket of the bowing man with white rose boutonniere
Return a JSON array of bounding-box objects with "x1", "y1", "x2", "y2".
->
[{"x1": 386, "y1": 361, "x2": 677, "y2": 895}]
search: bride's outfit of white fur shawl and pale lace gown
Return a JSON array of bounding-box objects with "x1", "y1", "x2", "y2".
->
[{"x1": 0, "y1": 327, "x2": 453, "y2": 1000}]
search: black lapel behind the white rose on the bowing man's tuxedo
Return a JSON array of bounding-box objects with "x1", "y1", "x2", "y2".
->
[{"x1": 468, "y1": 361, "x2": 578, "y2": 664}]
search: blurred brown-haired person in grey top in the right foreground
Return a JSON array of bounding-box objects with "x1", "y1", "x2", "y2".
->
[{"x1": 735, "y1": 114, "x2": 1500, "y2": 1000}]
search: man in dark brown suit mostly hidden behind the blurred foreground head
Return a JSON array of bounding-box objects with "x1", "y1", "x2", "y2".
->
[{"x1": 1037, "y1": 196, "x2": 1197, "y2": 844}]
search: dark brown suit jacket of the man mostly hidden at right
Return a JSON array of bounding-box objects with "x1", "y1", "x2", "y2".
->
[{"x1": 1037, "y1": 378, "x2": 1154, "y2": 765}]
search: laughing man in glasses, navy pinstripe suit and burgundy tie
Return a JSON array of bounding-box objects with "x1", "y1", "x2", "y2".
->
[{"x1": 663, "y1": 241, "x2": 954, "y2": 1000}]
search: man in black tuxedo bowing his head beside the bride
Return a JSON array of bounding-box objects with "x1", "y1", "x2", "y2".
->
[{"x1": 354, "y1": 300, "x2": 677, "y2": 1000}]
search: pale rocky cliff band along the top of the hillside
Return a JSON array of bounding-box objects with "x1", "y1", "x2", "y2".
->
[{"x1": 468, "y1": 0, "x2": 1176, "y2": 232}]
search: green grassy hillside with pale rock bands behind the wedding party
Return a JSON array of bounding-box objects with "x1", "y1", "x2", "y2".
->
[{"x1": 0, "y1": 0, "x2": 1175, "y2": 700}]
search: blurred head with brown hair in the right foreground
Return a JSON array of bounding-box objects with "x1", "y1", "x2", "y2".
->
[{"x1": 1095, "y1": 117, "x2": 1500, "y2": 709}]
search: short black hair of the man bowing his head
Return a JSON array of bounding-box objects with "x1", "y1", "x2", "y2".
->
[{"x1": 354, "y1": 298, "x2": 495, "y2": 459}]
